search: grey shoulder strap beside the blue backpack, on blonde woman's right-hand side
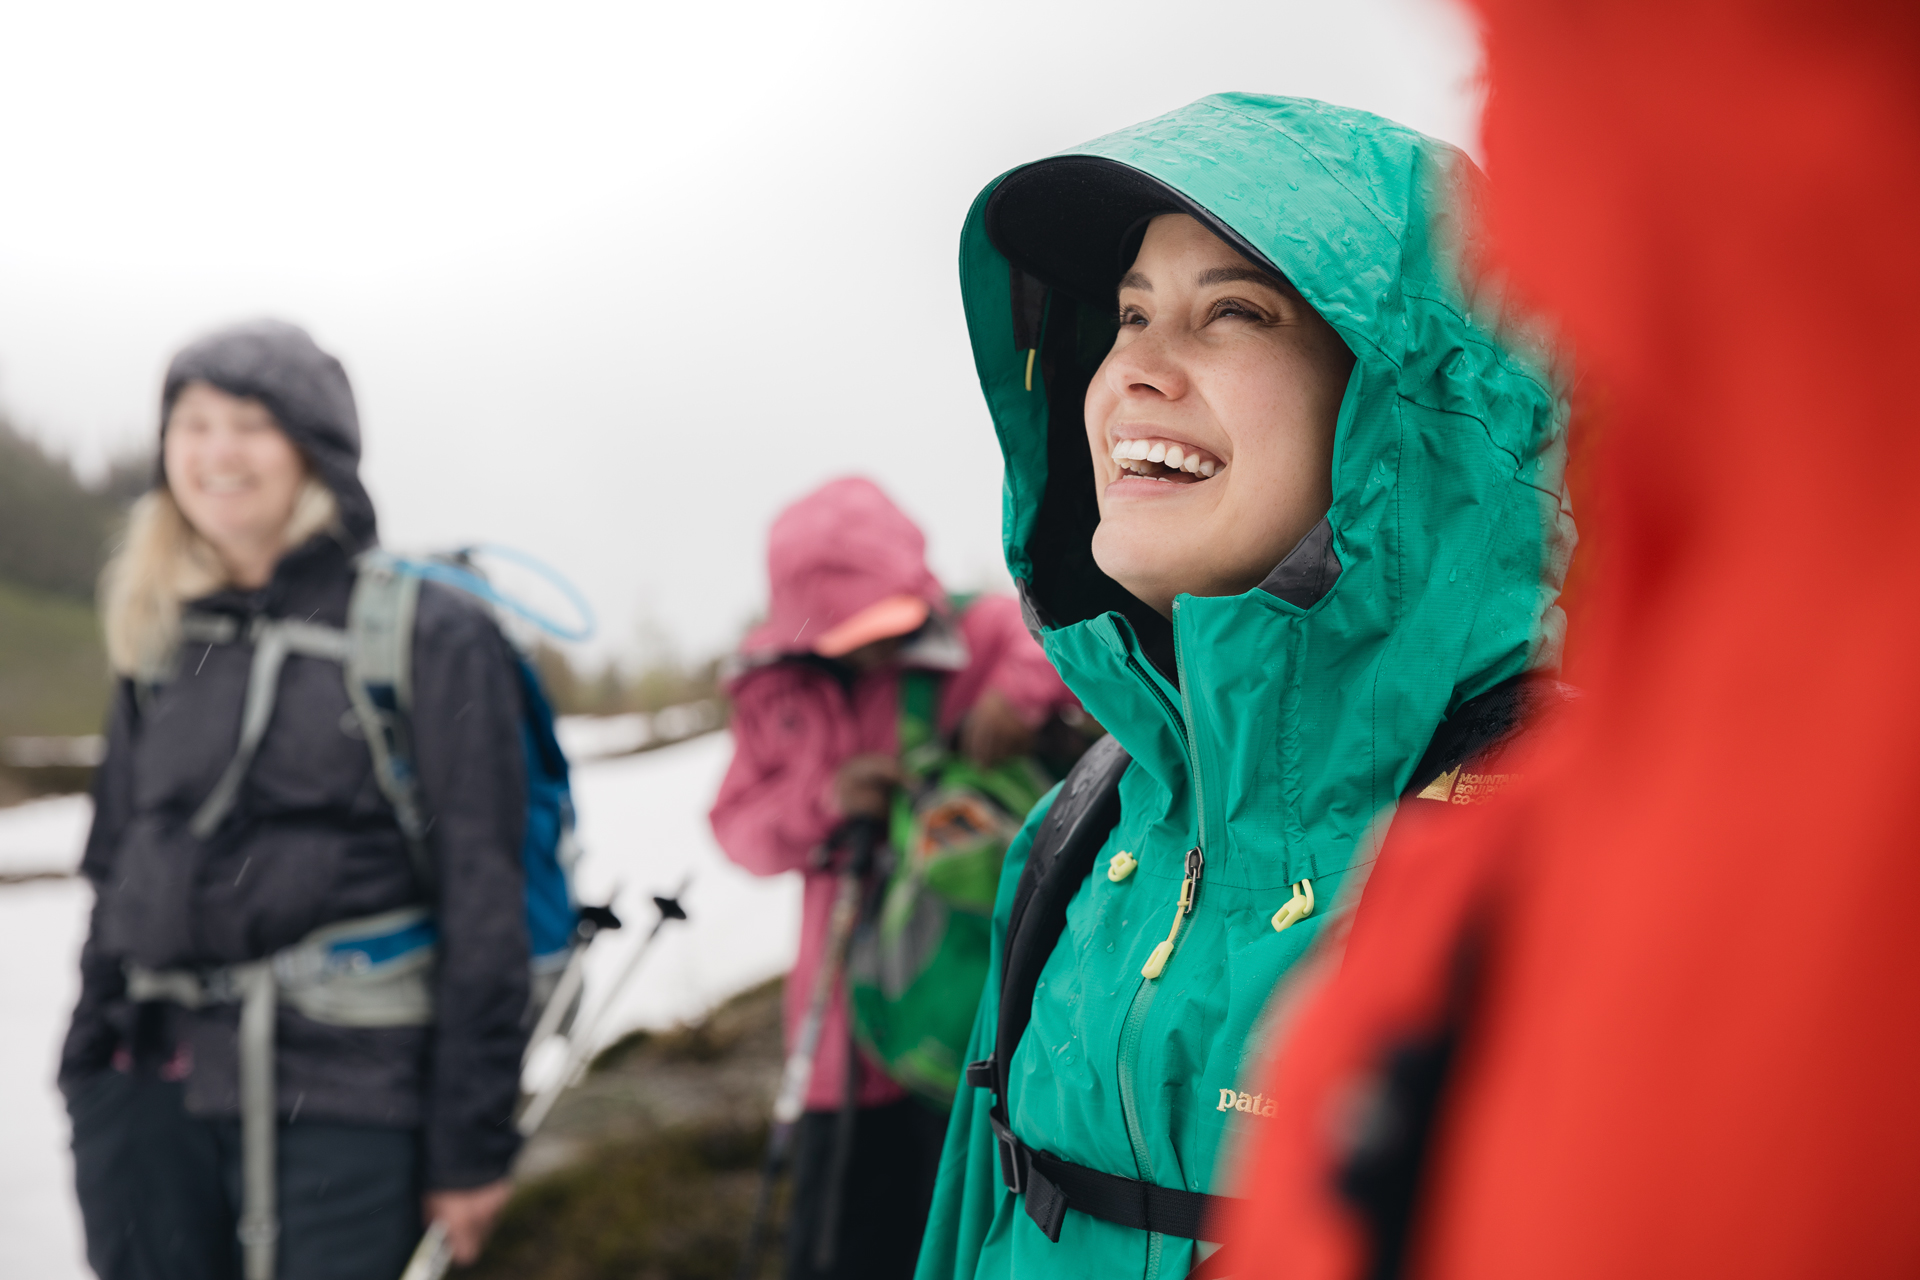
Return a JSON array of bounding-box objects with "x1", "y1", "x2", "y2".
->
[{"x1": 346, "y1": 551, "x2": 434, "y2": 885}]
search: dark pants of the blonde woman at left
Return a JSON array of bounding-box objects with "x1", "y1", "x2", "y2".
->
[{"x1": 67, "y1": 1071, "x2": 420, "y2": 1280}]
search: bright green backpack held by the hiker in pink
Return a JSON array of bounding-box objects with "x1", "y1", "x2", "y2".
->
[{"x1": 847, "y1": 670, "x2": 1054, "y2": 1107}]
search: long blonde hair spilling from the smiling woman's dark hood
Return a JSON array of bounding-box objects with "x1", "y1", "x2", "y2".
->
[{"x1": 100, "y1": 476, "x2": 340, "y2": 679}]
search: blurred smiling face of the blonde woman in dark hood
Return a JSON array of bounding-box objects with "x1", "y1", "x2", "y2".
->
[{"x1": 165, "y1": 382, "x2": 307, "y2": 585}]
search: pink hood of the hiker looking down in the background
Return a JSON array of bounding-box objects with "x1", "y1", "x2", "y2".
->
[{"x1": 741, "y1": 476, "x2": 947, "y2": 658}]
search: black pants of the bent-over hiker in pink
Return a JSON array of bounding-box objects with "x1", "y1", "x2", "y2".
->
[{"x1": 787, "y1": 1100, "x2": 947, "y2": 1280}]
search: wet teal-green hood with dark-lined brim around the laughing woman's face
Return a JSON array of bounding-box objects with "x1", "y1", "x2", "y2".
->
[{"x1": 960, "y1": 94, "x2": 1574, "y2": 885}]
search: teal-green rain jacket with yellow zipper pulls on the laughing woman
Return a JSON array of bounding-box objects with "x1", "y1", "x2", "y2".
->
[{"x1": 918, "y1": 94, "x2": 1574, "y2": 1280}]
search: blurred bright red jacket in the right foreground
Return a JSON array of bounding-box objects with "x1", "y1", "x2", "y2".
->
[{"x1": 1221, "y1": 0, "x2": 1920, "y2": 1280}]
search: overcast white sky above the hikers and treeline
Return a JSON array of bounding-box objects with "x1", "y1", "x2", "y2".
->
[{"x1": 0, "y1": 0, "x2": 1478, "y2": 671}]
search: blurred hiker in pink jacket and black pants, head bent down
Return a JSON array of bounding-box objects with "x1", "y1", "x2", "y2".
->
[{"x1": 710, "y1": 478, "x2": 1077, "y2": 1280}]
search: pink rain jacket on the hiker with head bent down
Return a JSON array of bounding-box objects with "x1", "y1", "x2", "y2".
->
[{"x1": 710, "y1": 480, "x2": 1073, "y2": 1109}]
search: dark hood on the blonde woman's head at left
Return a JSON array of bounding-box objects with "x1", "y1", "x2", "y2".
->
[{"x1": 157, "y1": 320, "x2": 376, "y2": 551}]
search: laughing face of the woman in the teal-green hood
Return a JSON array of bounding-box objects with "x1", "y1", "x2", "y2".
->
[{"x1": 1087, "y1": 213, "x2": 1354, "y2": 614}]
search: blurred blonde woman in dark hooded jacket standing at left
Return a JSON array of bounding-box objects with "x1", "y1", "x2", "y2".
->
[{"x1": 61, "y1": 320, "x2": 528, "y2": 1280}]
